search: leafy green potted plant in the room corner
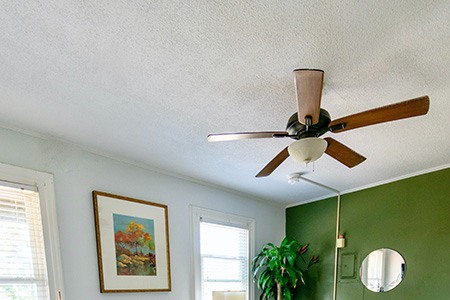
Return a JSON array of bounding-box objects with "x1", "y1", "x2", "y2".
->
[{"x1": 252, "y1": 237, "x2": 319, "y2": 300}]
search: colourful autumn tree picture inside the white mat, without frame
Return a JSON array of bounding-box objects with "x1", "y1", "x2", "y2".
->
[{"x1": 113, "y1": 214, "x2": 156, "y2": 276}]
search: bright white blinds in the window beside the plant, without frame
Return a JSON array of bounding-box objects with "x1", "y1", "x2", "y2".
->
[{"x1": 200, "y1": 220, "x2": 249, "y2": 300}]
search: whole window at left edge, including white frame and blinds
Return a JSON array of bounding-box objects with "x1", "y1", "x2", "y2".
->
[{"x1": 0, "y1": 164, "x2": 62, "y2": 300}]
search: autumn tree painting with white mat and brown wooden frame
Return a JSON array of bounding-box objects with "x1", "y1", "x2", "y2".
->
[{"x1": 92, "y1": 191, "x2": 171, "y2": 293}]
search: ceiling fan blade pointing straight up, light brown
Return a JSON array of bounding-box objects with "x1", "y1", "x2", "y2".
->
[{"x1": 294, "y1": 69, "x2": 323, "y2": 125}]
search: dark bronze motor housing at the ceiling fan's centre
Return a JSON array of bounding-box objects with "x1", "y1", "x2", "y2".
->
[{"x1": 286, "y1": 108, "x2": 331, "y2": 140}]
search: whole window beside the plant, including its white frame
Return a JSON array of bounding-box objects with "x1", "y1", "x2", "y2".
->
[{"x1": 193, "y1": 208, "x2": 254, "y2": 300}]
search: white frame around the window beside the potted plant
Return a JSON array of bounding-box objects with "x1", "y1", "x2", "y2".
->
[{"x1": 191, "y1": 206, "x2": 255, "y2": 300}]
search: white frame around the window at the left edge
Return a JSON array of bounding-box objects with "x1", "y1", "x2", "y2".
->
[{"x1": 0, "y1": 163, "x2": 64, "y2": 300}]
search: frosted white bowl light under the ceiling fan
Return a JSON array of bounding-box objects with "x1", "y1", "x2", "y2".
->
[{"x1": 288, "y1": 137, "x2": 328, "y2": 163}]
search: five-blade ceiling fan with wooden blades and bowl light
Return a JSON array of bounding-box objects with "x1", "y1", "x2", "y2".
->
[{"x1": 208, "y1": 69, "x2": 430, "y2": 177}]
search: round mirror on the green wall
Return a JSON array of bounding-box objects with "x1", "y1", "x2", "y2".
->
[{"x1": 360, "y1": 248, "x2": 406, "y2": 292}]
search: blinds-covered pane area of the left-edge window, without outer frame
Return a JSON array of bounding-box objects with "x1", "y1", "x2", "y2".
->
[{"x1": 0, "y1": 182, "x2": 50, "y2": 300}]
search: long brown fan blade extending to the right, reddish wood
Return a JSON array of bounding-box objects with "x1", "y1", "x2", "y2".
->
[{"x1": 330, "y1": 96, "x2": 430, "y2": 132}]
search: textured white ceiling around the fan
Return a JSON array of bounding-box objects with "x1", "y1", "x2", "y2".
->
[{"x1": 0, "y1": 0, "x2": 450, "y2": 205}]
